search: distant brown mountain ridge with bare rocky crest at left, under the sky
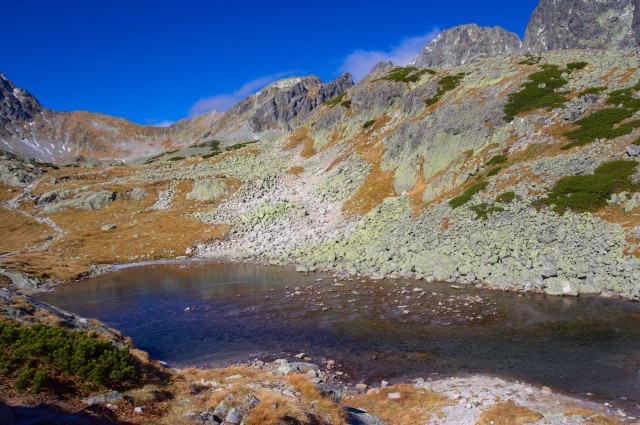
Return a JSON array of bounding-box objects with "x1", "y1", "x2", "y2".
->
[{"x1": 0, "y1": 74, "x2": 353, "y2": 162}]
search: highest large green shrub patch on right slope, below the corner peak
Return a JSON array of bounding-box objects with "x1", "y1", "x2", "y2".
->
[{"x1": 504, "y1": 65, "x2": 568, "y2": 122}]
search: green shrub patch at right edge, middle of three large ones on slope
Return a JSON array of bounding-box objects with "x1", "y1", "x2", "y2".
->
[{"x1": 562, "y1": 108, "x2": 640, "y2": 150}]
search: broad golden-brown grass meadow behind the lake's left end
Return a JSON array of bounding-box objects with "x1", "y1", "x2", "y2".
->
[{"x1": 0, "y1": 167, "x2": 230, "y2": 281}]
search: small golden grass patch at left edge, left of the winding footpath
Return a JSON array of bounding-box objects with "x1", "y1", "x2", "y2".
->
[{"x1": 0, "y1": 207, "x2": 53, "y2": 253}]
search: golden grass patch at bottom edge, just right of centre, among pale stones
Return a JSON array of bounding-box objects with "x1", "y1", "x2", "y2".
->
[{"x1": 344, "y1": 384, "x2": 450, "y2": 425}]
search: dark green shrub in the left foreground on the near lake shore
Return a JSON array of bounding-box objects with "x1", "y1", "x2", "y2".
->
[{"x1": 0, "y1": 323, "x2": 138, "y2": 392}]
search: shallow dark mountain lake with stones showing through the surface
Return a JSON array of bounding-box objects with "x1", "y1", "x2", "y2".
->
[{"x1": 38, "y1": 264, "x2": 640, "y2": 404}]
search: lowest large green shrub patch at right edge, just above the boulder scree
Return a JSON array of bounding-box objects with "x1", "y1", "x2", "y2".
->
[{"x1": 543, "y1": 161, "x2": 640, "y2": 213}]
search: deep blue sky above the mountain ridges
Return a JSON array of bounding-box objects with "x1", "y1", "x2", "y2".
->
[{"x1": 0, "y1": 0, "x2": 538, "y2": 124}]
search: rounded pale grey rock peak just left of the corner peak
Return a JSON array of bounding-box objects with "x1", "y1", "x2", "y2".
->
[{"x1": 414, "y1": 24, "x2": 522, "y2": 68}]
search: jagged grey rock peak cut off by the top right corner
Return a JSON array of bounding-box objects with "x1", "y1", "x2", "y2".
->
[{"x1": 523, "y1": 0, "x2": 640, "y2": 51}]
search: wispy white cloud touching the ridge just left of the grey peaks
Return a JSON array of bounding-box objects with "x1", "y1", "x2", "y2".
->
[{"x1": 340, "y1": 29, "x2": 440, "y2": 82}]
